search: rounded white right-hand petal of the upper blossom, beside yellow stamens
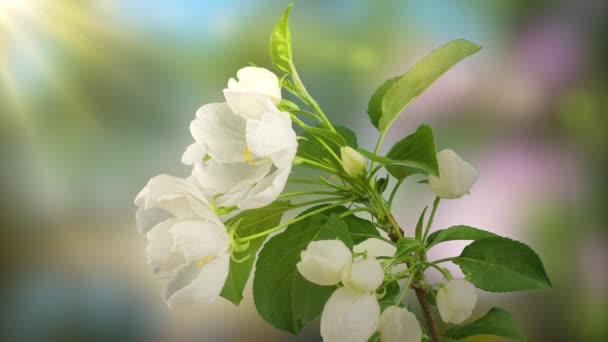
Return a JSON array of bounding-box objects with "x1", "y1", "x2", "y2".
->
[{"x1": 247, "y1": 112, "x2": 298, "y2": 168}]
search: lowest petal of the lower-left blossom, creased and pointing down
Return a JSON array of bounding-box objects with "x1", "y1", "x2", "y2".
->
[{"x1": 163, "y1": 254, "x2": 230, "y2": 310}]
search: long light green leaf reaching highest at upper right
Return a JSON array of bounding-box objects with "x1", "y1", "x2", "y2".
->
[{"x1": 370, "y1": 39, "x2": 481, "y2": 132}]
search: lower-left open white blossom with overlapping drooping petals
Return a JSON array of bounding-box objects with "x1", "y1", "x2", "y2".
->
[{"x1": 135, "y1": 175, "x2": 230, "y2": 309}]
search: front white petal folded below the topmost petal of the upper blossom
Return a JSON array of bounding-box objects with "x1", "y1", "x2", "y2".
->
[{"x1": 224, "y1": 89, "x2": 277, "y2": 120}]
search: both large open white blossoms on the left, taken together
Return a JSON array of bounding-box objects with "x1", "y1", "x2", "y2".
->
[{"x1": 135, "y1": 66, "x2": 298, "y2": 309}]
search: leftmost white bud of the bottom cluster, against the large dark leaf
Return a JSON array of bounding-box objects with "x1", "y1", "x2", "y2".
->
[{"x1": 296, "y1": 240, "x2": 352, "y2": 286}]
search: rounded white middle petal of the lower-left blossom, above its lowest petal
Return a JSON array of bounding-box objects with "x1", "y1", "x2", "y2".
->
[{"x1": 169, "y1": 221, "x2": 230, "y2": 262}]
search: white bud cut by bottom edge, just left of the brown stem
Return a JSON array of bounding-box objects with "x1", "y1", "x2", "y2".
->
[{"x1": 378, "y1": 306, "x2": 422, "y2": 342}]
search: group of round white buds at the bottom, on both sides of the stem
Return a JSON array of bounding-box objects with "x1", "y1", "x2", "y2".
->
[{"x1": 297, "y1": 238, "x2": 477, "y2": 342}]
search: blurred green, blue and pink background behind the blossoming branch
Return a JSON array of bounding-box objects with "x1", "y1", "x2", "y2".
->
[{"x1": 0, "y1": 0, "x2": 608, "y2": 341}]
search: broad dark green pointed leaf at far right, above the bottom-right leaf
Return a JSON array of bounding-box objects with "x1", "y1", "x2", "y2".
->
[{"x1": 452, "y1": 236, "x2": 551, "y2": 292}]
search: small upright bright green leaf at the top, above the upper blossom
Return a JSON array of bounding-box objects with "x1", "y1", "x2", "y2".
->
[{"x1": 270, "y1": 4, "x2": 293, "y2": 74}]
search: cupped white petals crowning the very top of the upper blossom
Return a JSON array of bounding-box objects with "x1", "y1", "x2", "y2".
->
[{"x1": 224, "y1": 66, "x2": 281, "y2": 119}]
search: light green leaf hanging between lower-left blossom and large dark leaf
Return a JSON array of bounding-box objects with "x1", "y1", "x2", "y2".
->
[{"x1": 221, "y1": 201, "x2": 291, "y2": 305}]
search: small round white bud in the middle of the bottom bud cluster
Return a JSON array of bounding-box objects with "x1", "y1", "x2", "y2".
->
[{"x1": 342, "y1": 258, "x2": 384, "y2": 292}]
